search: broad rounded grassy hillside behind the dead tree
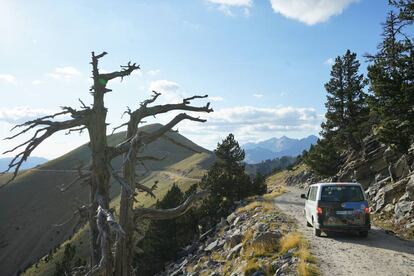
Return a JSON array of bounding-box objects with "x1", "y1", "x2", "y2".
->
[{"x1": 0, "y1": 125, "x2": 214, "y2": 275}]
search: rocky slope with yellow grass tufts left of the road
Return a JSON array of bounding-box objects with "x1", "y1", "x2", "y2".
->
[{"x1": 160, "y1": 190, "x2": 317, "y2": 276}]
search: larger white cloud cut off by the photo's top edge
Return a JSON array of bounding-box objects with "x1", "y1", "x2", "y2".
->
[{"x1": 270, "y1": 0, "x2": 359, "y2": 25}]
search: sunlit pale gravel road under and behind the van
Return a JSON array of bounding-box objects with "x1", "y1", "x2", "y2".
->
[{"x1": 275, "y1": 188, "x2": 414, "y2": 276}]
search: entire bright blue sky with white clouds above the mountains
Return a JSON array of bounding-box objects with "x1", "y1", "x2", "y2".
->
[{"x1": 0, "y1": 0, "x2": 389, "y2": 158}]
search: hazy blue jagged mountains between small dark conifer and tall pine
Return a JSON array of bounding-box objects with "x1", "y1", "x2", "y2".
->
[{"x1": 243, "y1": 135, "x2": 318, "y2": 164}]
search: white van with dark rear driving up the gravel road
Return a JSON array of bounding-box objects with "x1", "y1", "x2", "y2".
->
[{"x1": 301, "y1": 183, "x2": 371, "y2": 237}]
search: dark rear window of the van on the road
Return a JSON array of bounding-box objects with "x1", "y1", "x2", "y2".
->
[{"x1": 321, "y1": 185, "x2": 365, "y2": 202}]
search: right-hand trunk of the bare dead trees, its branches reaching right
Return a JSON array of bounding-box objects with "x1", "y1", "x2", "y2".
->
[{"x1": 111, "y1": 91, "x2": 213, "y2": 276}]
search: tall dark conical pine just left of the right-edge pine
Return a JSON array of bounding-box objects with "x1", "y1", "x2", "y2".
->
[{"x1": 321, "y1": 50, "x2": 368, "y2": 149}]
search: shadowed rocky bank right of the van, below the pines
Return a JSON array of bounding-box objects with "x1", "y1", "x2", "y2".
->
[{"x1": 282, "y1": 137, "x2": 414, "y2": 240}]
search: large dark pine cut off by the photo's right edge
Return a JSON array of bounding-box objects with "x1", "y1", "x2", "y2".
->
[{"x1": 368, "y1": 12, "x2": 414, "y2": 152}]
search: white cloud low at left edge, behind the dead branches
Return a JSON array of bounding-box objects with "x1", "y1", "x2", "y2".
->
[{"x1": 0, "y1": 106, "x2": 56, "y2": 124}]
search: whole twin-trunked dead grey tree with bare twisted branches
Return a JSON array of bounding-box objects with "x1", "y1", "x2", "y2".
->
[{"x1": 3, "y1": 52, "x2": 212, "y2": 275}]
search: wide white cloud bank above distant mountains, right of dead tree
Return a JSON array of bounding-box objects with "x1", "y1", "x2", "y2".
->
[{"x1": 179, "y1": 106, "x2": 323, "y2": 149}]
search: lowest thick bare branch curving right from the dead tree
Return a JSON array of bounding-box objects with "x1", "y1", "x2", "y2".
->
[{"x1": 134, "y1": 191, "x2": 209, "y2": 220}]
